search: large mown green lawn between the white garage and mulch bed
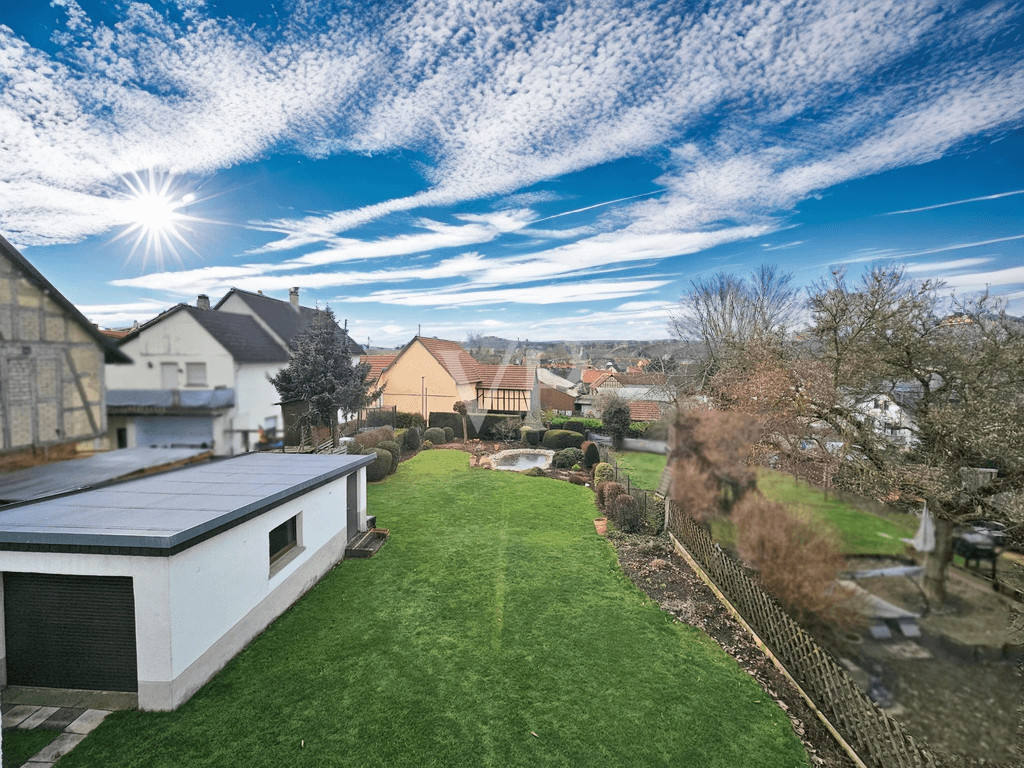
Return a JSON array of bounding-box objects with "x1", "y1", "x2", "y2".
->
[{"x1": 59, "y1": 451, "x2": 807, "y2": 768}]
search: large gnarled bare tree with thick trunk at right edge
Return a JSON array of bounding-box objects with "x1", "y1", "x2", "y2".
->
[{"x1": 807, "y1": 267, "x2": 1024, "y2": 604}]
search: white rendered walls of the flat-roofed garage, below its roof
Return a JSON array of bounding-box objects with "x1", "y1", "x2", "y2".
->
[{"x1": 0, "y1": 468, "x2": 367, "y2": 710}]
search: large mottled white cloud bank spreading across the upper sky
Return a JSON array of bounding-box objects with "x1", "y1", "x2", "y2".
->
[{"x1": 0, "y1": 0, "x2": 1024, "y2": 252}]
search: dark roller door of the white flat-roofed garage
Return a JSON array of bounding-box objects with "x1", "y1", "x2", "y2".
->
[{"x1": 3, "y1": 571, "x2": 138, "y2": 691}]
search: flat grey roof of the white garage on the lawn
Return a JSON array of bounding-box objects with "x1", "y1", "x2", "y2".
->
[{"x1": 0, "y1": 453, "x2": 375, "y2": 556}]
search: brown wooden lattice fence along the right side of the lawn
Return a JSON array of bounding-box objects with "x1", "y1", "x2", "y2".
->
[{"x1": 666, "y1": 501, "x2": 958, "y2": 768}]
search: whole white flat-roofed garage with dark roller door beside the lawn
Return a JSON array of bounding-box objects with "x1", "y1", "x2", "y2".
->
[{"x1": 0, "y1": 453, "x2": 373, "y2": 710}]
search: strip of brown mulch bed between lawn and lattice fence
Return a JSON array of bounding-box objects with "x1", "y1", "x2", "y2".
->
[{"x1": 609, "y1": 534, "x2": 854, "y2": 768}]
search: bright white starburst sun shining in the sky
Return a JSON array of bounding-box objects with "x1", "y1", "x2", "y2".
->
[{"x1": 115, "y1": 170, "x2": 204, "y2": 267}]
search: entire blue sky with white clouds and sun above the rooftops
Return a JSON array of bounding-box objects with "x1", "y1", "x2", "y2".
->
[{"x1": 0, "y1": 0, "x2": 1024, "y2": 345}]
